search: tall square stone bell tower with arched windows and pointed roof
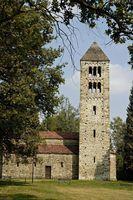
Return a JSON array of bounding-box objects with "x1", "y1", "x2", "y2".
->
[{"x1": 79, "y1": 42, "x2": 110, "y2": 180}]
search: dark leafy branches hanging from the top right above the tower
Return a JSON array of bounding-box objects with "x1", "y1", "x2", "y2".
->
[{"x1": 52, "y1": 0, "x2": 133, "y2": 43}]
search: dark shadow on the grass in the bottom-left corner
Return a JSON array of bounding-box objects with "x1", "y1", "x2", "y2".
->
[{"x1": 0, "y1": 193, "x2": 38, "y2": 200}]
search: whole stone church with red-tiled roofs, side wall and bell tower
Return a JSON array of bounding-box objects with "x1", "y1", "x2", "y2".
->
[{"x1": 3, "y1": 42, "x2": 116, "y2": 180}]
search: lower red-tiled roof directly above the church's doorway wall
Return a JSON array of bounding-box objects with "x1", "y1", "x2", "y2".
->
[{"x1": 38, "y1": 145, "x2": 78, "y2": 154}]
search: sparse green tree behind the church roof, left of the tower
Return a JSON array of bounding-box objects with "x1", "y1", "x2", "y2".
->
[{"x1": 40, "y1": 96, "x2": 79, "y2": 133}]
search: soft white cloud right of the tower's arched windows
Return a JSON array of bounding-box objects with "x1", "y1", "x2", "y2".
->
[{"x1": 110, "y1": 64, "x2": 133, "y2": 95}]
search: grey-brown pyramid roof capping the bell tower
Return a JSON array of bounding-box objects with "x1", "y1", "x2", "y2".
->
[{"x1": 81, "y1": 42, "x2": 109, "y2": 61}]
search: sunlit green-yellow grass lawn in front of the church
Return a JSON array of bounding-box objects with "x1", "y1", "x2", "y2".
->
[{"x1": 0, "y1": 180, "x2": 133, "y2": 200}]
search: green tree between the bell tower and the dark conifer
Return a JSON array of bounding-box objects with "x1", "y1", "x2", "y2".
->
[{"x1": 111, "y1": 117, "x2": 126, "y2": 180}]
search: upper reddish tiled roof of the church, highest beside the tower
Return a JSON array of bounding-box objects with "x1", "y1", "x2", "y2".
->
[{"x1": 39, "y1": 131, "x2": 79, "y2": 140}]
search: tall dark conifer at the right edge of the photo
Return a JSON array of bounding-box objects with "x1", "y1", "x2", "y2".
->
[{"x1": 124, "y1": 86, "x2": 133, "y2": 180}]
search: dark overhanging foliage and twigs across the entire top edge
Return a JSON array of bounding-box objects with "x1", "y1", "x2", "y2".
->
[{"x1": 0, "y1": 0, "x2": 133, "y2": 65}]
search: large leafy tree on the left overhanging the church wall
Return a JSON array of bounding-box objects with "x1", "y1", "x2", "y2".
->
[{"x1": 0, "y1": 1, "x2": 64, "y2": 178}]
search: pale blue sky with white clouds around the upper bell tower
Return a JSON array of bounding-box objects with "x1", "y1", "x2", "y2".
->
[{"x1": 54, "y1": 21, "x2": 133, "y2": 120}]
